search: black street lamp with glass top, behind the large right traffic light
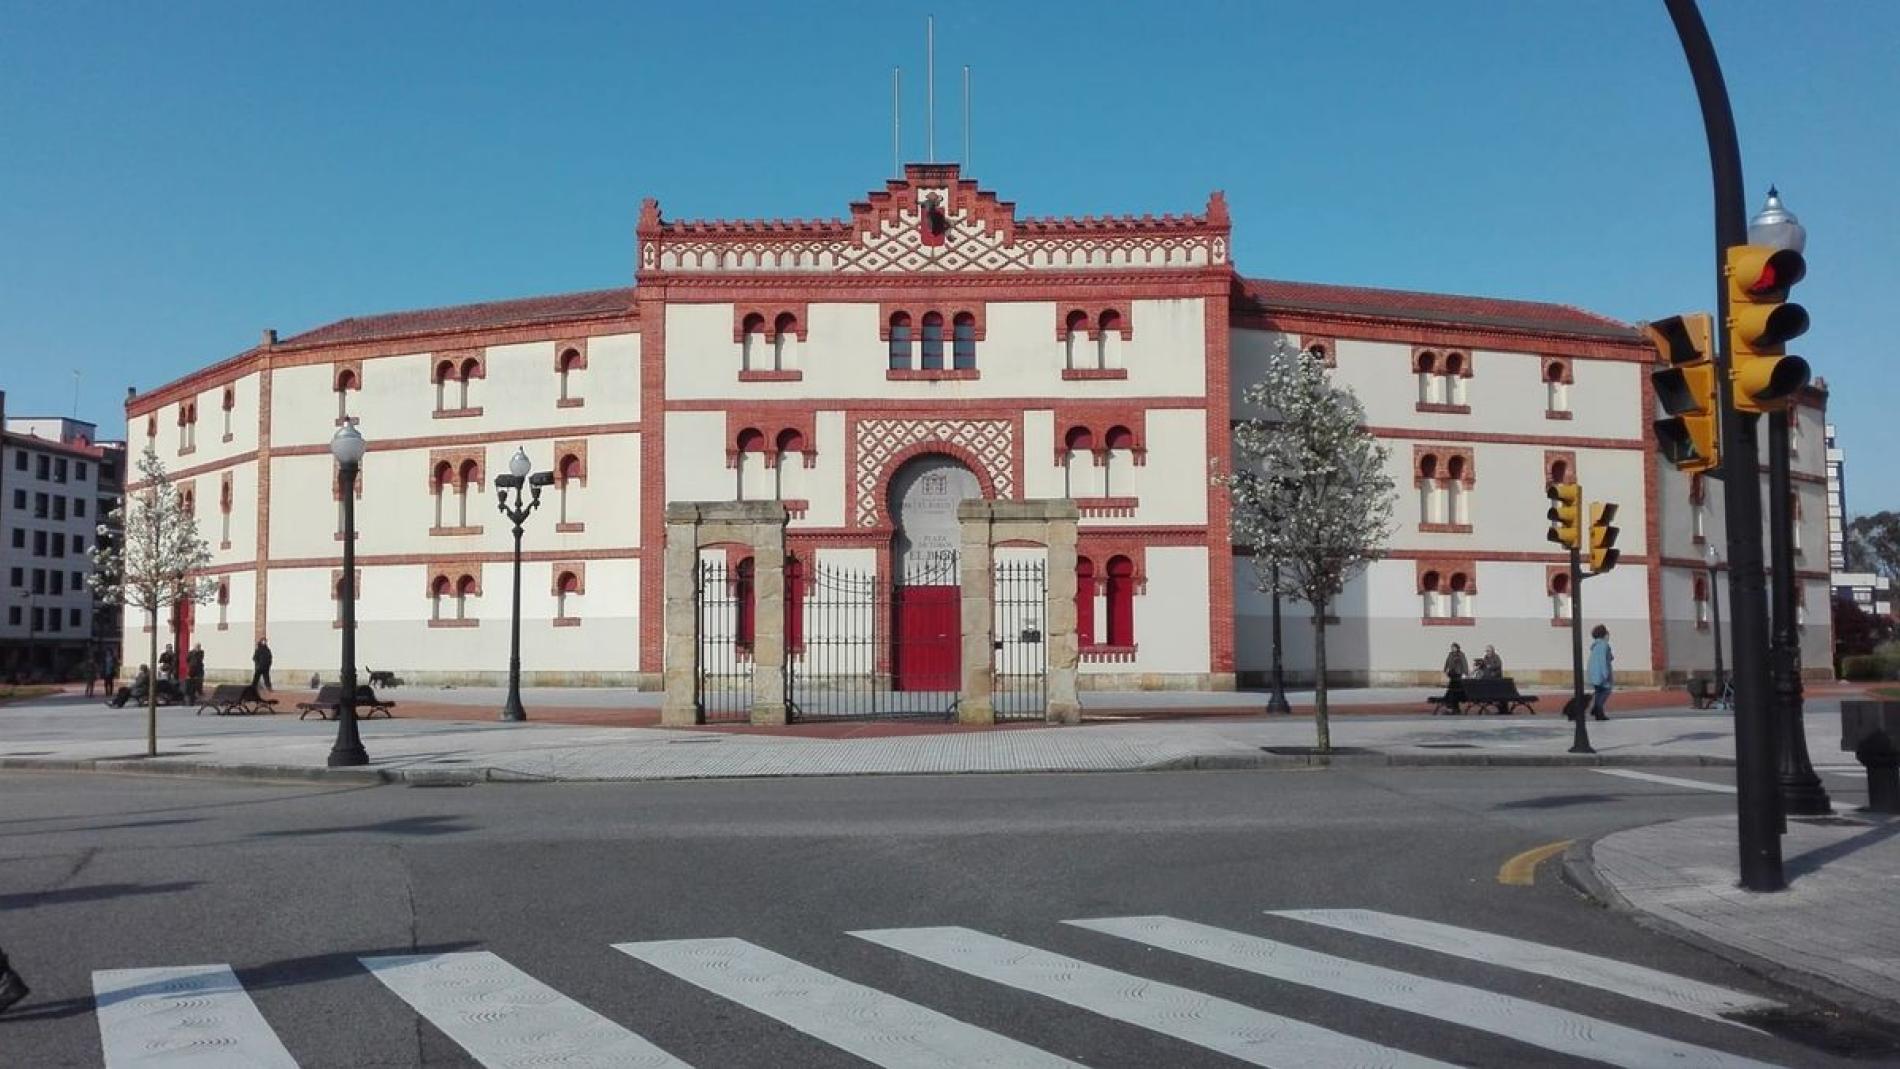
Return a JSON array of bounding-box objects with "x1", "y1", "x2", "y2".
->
[{"x1": 1748, "y1": 186, "x2": 1834, "y2": 816}]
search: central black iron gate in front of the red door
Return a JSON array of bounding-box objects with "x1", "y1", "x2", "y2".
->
[{"x1": 785, "y1": 553, "x2": 963, "y2": 722}]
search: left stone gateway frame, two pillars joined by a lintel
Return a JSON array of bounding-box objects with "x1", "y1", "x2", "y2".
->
[{"x1": 659, "y1": 501, "x2": 790, "y2": 727}]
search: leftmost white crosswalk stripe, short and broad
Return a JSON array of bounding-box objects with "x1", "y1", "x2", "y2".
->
[{"x1": 93, "y1": 965, "x2": 296, "y2": 1069}]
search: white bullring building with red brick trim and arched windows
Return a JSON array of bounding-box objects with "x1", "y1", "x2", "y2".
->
[{"x1": 114, "y1": 163, "x2": 1830, "y2": 689}]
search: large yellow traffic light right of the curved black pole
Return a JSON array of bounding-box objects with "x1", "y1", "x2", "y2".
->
[{"x1": 1725, "y1": 245, "x2": 1809, "y2": 412}]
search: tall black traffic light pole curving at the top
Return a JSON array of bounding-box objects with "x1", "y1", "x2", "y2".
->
[{"x1": 1663, "y1": 0, "x2": 1788, "y2": 891}]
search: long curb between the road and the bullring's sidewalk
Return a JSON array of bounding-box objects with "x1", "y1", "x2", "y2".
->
[{"x1": 0, "y1": 752, "x2": 1735, "y2": 786}]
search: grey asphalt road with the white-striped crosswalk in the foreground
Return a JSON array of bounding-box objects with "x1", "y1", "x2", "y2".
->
[{"x1": 0, "y1": 769, "x2": 1900, "y2": 1069}]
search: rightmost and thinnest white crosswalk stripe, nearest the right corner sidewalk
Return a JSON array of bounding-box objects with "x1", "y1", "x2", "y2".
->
[{"x1": 1269, "y1": 910, "x2": 1778, "y2": 1023}]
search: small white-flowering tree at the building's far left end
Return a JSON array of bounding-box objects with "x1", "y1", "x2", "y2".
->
[{"x1": 87, "y1": 446, "x2": 217, "y2": 758}]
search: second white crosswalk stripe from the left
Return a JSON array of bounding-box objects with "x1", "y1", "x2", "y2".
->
[{"x1": 359, "y1": 951, "x2": 690, "y2": 1069}]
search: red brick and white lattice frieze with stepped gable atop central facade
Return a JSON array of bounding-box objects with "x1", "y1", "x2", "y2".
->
[{"x1": 638, "y1": 163, "x2": 1231, "y2": 275}]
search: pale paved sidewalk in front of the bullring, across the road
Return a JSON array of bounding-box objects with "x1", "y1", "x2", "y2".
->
[{"x1": 0, "y1": 691, "x2": 1837, "y2": 782}]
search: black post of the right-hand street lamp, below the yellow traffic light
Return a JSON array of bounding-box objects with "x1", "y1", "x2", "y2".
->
[{"x1": 1769, "y1": 406, "x2": 1834, "y2": 816}]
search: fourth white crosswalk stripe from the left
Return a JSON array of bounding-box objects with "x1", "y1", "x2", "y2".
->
[{"x1": 851, "y1": 928, "x2": 1446, "y2": 1069}]
